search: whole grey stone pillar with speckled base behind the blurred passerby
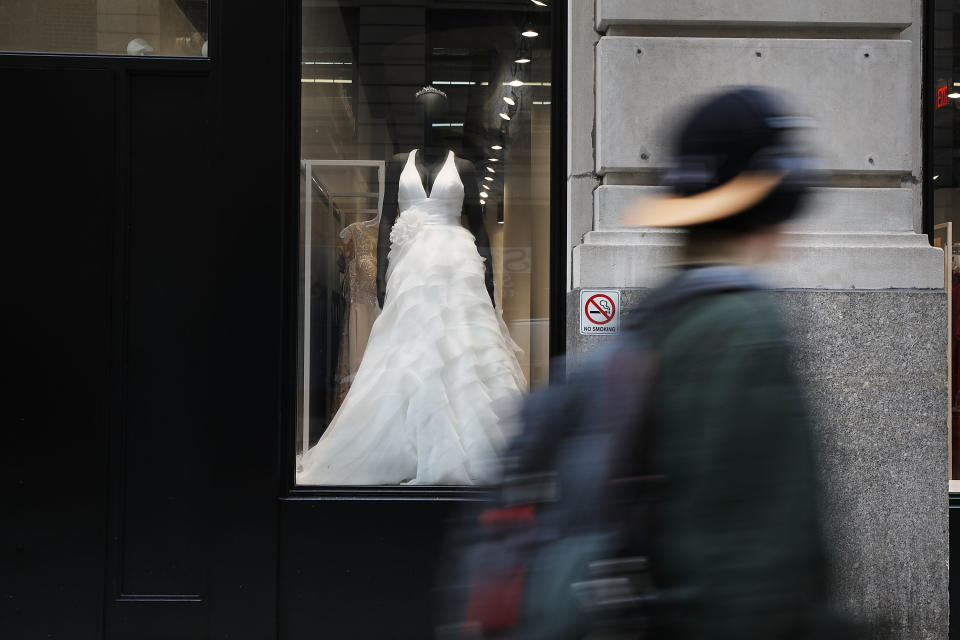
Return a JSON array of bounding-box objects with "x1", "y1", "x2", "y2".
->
[{"x1": 567, "y1": 0, "x2": 949, "y2": 638}]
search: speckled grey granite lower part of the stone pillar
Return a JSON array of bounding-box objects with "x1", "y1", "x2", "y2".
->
[{"x1": 567, "y1": 289, "x2": 948, "y2": 638}]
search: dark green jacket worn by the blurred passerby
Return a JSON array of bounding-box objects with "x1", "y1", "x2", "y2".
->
[{"x1": 651, "y1": 276, "x2": 847, "y2": 640}]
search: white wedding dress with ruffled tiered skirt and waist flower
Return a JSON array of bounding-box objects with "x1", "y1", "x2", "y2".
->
[{"x1": 297, "y1": 150, "x2": 526, "y2": 485}]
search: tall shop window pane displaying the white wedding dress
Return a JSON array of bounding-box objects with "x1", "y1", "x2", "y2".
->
[{"x1": 297, "y1": 0, "x2": 562, "y2": 485}]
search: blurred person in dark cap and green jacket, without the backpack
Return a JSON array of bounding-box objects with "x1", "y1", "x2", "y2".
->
[{"x1": 628, "y1": 87, "x2": 850, "y2": 639}]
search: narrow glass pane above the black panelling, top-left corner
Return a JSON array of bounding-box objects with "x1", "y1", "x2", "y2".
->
[{"x1": 0, "y1": 0, "x2": 209, "y2": 57}]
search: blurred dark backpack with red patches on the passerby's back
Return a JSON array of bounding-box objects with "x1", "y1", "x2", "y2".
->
[{"x1": 438, "y1": 267, "x2": 756, "y2": 640}]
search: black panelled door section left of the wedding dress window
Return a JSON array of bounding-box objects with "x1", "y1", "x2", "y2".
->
[{"x1": 0, "y1": 2, "x2": 290, "y2": 638}]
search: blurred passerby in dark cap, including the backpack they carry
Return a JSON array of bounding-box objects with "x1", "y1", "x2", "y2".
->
[{"x1": 440, "y1": 87, "x2": 851, "y2": 640}]
